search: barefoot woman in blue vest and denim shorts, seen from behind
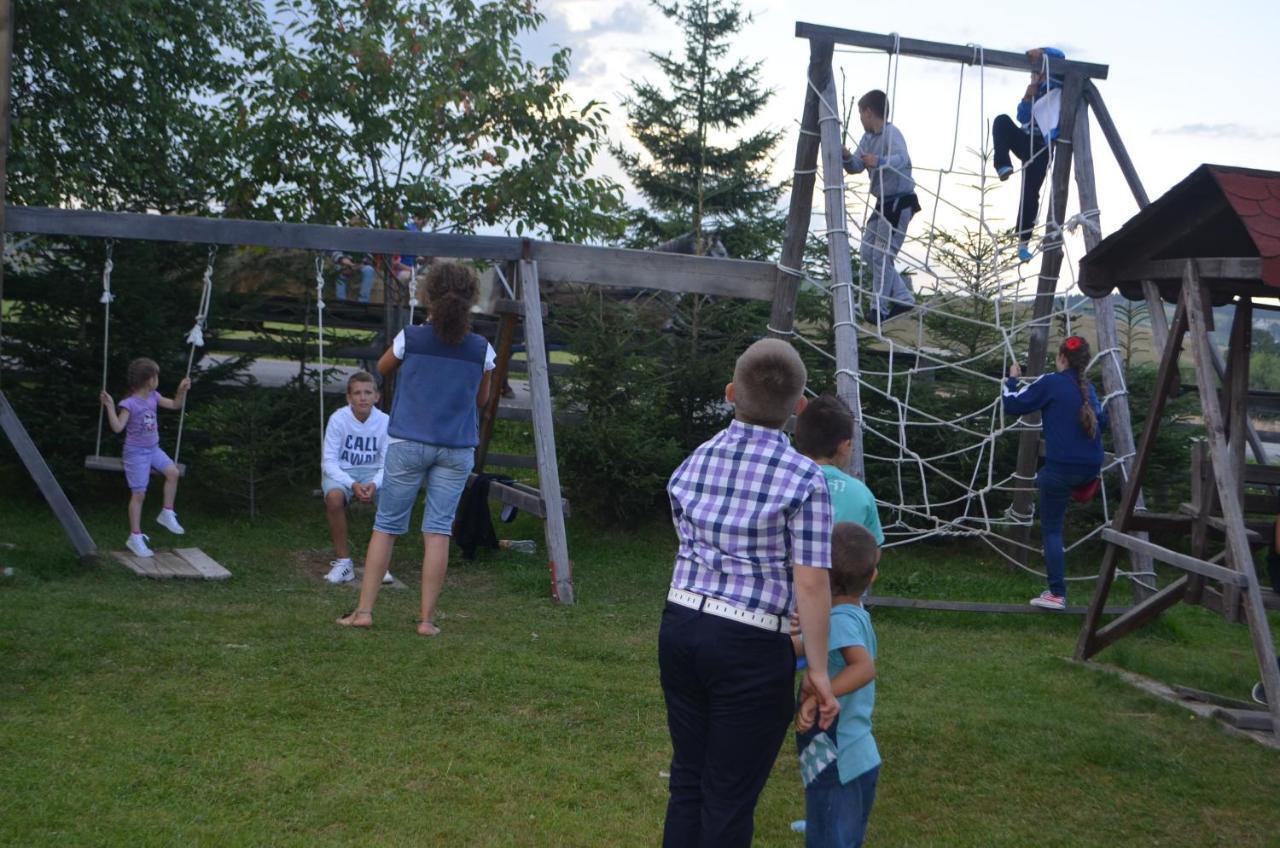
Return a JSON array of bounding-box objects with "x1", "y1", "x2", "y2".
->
[{"x1": 338, "y1": 263, "x2": 497, "y2": 635}]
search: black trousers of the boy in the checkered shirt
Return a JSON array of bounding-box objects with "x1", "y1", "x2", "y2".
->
[{"x1": 658, "y1": 603, "x2": 795, "y2": 848}]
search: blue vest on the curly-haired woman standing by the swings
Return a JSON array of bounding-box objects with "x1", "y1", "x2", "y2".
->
[{"x1": 387, "y1": 324, "x2": 489, "y2": 447}]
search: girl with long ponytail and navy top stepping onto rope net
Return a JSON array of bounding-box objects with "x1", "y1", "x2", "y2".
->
[{"x1": 1001, "y1": 336, "x2": 1108, "y2": 610}]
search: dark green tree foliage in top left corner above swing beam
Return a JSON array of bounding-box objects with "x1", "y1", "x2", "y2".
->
[{"x1": 9, "y1": 0, "x2": 268, "y2": 213}]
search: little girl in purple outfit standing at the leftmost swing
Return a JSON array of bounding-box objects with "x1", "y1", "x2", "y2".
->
[{"x1": 99, "y1": 356, "x2": 191, "y2": 556}]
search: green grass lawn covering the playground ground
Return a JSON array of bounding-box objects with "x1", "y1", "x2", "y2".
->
[{"x1": 0, "y1": 484, "x2": 1280, "y2": 847}]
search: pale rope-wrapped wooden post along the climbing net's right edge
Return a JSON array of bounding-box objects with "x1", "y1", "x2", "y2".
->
[{"x1": 1073, "y1": 106, "x2": 1156, "y2": 603}]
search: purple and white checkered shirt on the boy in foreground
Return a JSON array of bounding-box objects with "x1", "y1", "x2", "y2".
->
[{"x1": 667, "y1": 421, "x2": 831, "y2": 615}]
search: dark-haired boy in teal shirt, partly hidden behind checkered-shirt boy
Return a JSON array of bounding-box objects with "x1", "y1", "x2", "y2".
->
[{"x1": 796, "y1": 395, "x2": 884, "y2": 544}]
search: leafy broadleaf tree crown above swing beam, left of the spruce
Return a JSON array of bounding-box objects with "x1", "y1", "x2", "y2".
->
[{"x1": 233, "y1": 0, "x2": 621, "y2": 241}]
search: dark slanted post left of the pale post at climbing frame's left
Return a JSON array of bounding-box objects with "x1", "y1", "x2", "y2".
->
[{"x1": 768, "y1": 41, "x2": 833, "y2": 338}]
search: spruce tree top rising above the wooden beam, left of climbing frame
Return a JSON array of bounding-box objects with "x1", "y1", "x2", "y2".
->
[{"x1": 613, "y1": 0, "x2": 785, "y2": 259}]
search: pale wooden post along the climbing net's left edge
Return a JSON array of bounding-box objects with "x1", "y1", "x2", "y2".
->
[{"x1": 818, "y1": 73, "x2": 867, "y2": 480}]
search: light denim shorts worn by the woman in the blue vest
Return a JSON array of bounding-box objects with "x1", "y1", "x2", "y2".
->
[{"x1": 374, "y1": 442, "x2": 475, "y2": 535}]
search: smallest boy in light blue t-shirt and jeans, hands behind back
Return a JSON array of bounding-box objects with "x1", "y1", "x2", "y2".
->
[{"x1": 792, "y1": 521, "x2": 881, "y2": 848}]
